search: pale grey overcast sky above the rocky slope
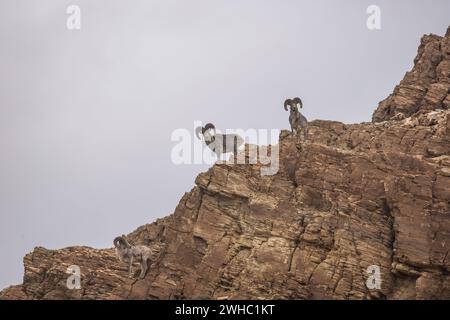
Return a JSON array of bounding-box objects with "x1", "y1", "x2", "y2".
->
[{"x1": 0, "y1": 0, "x2": 450, "y2": 288}]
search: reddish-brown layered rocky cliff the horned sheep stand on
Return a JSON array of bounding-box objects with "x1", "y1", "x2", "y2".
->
[{"x1": 0, "y1": 27, "x2": 450, "y2": 299}]
